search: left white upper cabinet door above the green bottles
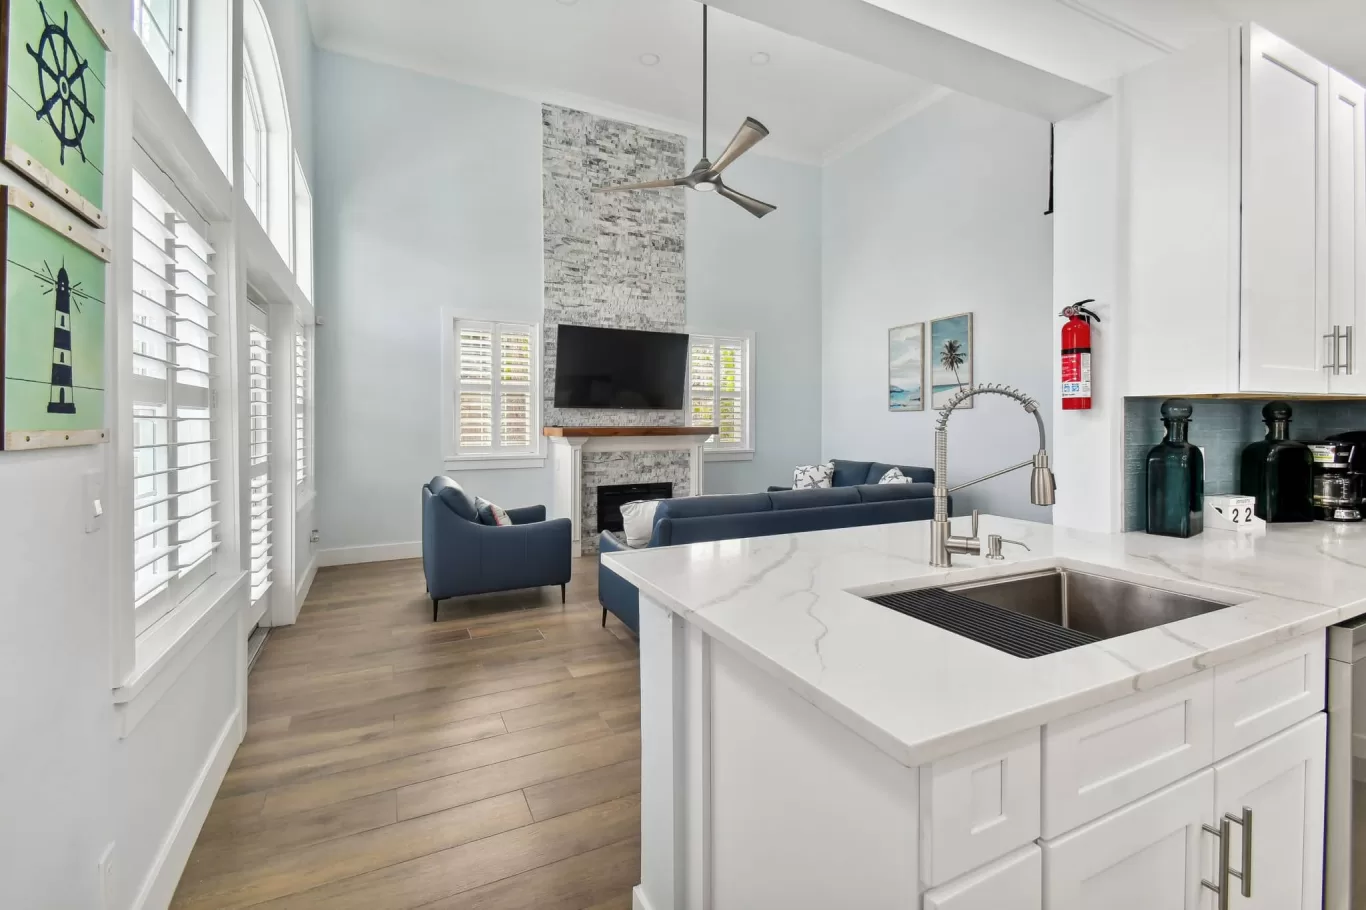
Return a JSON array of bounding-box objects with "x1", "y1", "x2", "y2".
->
[{"x1": 1240, "y1": 26, "x2": 1330, "y2": 392}]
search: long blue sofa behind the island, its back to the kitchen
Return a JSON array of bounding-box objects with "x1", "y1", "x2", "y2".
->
[{"x1": 598, "y1": 475, "x2": 952, "y2": 633}]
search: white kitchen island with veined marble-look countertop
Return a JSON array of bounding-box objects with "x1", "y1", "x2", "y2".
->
[{"x1": 604, "y1": 516, "x2": 1366, "y2": 910}]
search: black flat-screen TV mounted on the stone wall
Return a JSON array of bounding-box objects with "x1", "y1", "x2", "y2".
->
[{"x1": 555, "y1": 325, "x2": 687, "y2": 411}]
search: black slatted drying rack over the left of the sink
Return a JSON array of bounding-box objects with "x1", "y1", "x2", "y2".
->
[{"x1": 867, "y1": 588, "x2": 1100, "y2": 657}]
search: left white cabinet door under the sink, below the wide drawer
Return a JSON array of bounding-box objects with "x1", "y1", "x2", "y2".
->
[{"x1": 1044, "y1": 771, "x2": 1214, "y2": 910}]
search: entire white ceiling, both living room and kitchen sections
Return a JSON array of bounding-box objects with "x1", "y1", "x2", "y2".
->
[{"x1": 307, "y1": 0, "x2": 1366, "y2": 163}]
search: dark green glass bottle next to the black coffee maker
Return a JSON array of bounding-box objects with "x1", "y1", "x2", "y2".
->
[{"x1": 1238, "y1": 402, "x2": 1314, "y2": 522}]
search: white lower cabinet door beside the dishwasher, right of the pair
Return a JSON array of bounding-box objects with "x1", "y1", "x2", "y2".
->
[{"x1": 1214, "y1": 715, "x2": 1328, "y2": 910}]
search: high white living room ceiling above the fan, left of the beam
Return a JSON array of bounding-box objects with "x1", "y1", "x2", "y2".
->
[{"x1": 309, "y1": 0, "x2": 943, "y2": 163}]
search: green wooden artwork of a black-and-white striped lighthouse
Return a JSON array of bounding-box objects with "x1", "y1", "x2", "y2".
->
[{"x1": 0, "y1": 187, "x2": 109, "y2": 450}]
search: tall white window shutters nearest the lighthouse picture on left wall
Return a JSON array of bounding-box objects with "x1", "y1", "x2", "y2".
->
[{"x1": 131, "y1": 172, "x2": 219, "y2": 631}]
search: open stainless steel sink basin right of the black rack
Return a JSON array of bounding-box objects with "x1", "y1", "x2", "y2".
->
[{"x1": 944, "y1": 568, "x2": 1233, "y2": 639}]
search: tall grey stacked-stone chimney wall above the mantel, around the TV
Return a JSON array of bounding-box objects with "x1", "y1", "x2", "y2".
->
[{"x1": 541, "y1": 104, "x2": 687, "y2": 431}]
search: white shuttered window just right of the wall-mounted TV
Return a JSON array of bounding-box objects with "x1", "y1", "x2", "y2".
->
[{"x1": 688, "y1": 335, "x2": 753, "y2": 451}]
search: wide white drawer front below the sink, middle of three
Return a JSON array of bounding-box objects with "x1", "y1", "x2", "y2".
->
[{"x1": 1042, "y1": 670, "x2": 1214, "y2": 838}]
